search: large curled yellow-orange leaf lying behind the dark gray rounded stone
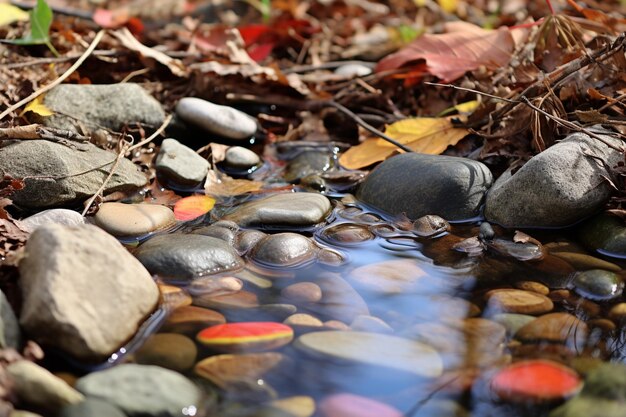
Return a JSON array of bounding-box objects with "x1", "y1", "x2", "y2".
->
[{"x1": 339, "y1": 117, "x2": 468, "y2": 169}]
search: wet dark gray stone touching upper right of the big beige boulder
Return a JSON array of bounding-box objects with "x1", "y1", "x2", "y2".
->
[{"x1": 135, "y1": 233, "x2": 244, "y2": 280}]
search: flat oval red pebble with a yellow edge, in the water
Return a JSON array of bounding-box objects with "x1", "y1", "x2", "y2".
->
[{"x1": 196, "y1": 322, "x2": 293, "y2": 352}]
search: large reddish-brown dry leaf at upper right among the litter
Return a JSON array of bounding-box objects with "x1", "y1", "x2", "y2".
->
[{"x1": 376, "y1": 22, "x2": 515, "y2": 82}]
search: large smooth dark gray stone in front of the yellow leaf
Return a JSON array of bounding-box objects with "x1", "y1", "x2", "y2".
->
[{"x1": 357, "y1": 153, "x2": 492, "y2": 220}]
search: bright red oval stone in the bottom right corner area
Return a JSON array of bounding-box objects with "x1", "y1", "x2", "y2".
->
[{"x1": 491, "y1": 360, "x2": 582, "y2": 403}]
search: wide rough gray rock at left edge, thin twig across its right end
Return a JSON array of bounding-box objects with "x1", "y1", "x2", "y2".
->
[{"x1": 0, "y1": 140, "x2": 148, "y2": 209}]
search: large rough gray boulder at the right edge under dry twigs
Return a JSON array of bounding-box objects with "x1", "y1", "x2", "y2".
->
[{"x1": 485, "y1": 128, "x2": 626, "y2": 227}]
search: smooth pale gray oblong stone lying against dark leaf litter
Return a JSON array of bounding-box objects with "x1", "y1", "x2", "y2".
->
[{"x1": 176, "y1": 97, "x2": 257, "y2": 140}]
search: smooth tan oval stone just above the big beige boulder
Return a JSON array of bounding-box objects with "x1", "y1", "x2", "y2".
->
[{"x1": 94, "y1": 203, "x2": 176, "y2": 237}]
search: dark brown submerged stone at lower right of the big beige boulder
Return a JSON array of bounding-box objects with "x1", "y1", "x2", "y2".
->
[{"x1": 134, "y1": 333, "x2": 198, "y2": 372}]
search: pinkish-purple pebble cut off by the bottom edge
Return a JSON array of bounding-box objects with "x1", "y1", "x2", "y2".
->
[{"x1": 319, "y1": 394, "x2": 404, "y2": 417}]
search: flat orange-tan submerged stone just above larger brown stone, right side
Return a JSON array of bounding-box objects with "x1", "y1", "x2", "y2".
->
[{"x1": 487, "y1": 289, "x2": 554, "y2": 315}]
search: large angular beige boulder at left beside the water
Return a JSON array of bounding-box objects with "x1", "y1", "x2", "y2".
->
[{"x1": 19, "y1": 224, "x2": 159, "y2": 361}]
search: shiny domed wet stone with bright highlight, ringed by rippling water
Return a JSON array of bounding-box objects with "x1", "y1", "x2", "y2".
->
[{"x1": 250, "y1": 233, "x2": 318, "y2": 267}]
